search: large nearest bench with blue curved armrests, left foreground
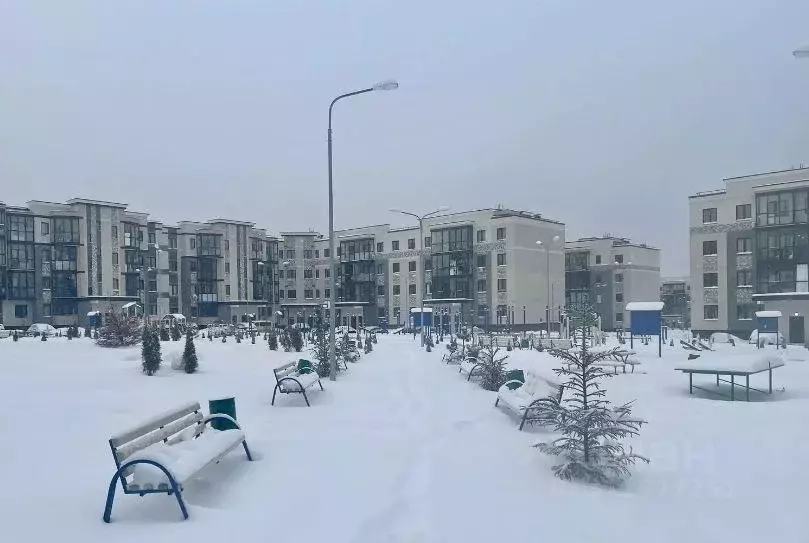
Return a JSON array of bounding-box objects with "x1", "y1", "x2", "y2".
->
[{"x1": 104, "y1": 402, "x2": 253, "y2": 522}]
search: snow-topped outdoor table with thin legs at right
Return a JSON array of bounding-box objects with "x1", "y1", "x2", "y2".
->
[{"x1": 674, "y1": 354, "x2": 784, "y2": 402}]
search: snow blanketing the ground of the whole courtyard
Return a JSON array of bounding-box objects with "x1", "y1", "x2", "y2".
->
[{"x1": 0, "y1": 336, "x2": 809, "y2": 543}]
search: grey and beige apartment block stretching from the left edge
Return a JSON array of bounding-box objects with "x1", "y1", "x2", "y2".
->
[{"x1": 0, "y1": 198, "x2": 278, "y2": 327}]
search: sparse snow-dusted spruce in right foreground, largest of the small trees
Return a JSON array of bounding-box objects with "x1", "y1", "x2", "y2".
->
[{"x1": 536, "y1": 305, "x2": 649, "y2": 487}]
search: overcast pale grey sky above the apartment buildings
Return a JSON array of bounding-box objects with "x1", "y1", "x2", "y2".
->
[{"x1": 0, "y1": 0, "x2": 809, "y2": 274}]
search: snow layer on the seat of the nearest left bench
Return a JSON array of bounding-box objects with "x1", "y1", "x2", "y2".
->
[{"x1": 127, "y1": 430, "x2": 244, "y2": 490}]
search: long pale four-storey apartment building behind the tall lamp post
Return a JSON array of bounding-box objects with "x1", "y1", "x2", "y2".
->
[{"x1": 279, "y1": 209, "x2": 564, "y2": 327}]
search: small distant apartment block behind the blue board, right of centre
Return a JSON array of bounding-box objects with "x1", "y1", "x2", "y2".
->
[{"x1": 557, "y1": 235, "x2": 660, "y2": 330}]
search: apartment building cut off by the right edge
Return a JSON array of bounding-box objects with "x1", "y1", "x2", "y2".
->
[{"x1": 689, "y1": 168, "x2": 809, "y2": 343}]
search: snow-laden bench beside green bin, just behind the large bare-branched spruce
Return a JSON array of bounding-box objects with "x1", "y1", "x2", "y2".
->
[{"x1": 494, "y1": 370, "x2": 564, "y2": 430}]
